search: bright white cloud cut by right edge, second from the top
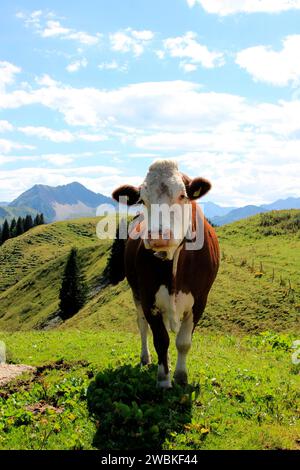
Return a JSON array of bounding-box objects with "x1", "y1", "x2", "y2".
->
[{"x1": 236, "y1": 34, "x2": 300, "y2": 86}]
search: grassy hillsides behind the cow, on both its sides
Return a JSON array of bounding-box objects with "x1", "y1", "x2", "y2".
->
[{"x1": 0, "y1": 210, "x2": 300, "y2": 332}]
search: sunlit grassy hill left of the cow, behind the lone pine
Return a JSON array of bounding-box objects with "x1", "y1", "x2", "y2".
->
[{"x1": 0, "y1": 218, "x2": 109, "y2": 329}]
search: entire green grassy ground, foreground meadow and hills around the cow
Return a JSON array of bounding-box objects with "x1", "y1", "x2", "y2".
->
[{"x1": 0, "y1": 210, "x2": 300, "y2": 449}]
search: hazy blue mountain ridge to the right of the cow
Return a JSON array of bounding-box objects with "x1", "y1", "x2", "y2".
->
[{"x1": 211, "y1": 197, "x2": 300, "y2": 225}]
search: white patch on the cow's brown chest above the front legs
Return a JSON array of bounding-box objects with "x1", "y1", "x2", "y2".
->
[{"x1": 154, "y1": 285, "x2": 194, "y2": 333}]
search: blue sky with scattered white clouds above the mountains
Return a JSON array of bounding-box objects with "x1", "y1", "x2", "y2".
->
[{"x1": 0, "y1": 0, "x2": 300, "y2": 206}]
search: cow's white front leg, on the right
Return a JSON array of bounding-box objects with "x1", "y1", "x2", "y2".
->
[{"x1": 174, "y1": 312, "x2": 194, "y2": 385}]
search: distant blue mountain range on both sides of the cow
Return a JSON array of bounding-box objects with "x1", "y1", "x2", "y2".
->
[{"x1": 0, "y1": 182, "x2": 300, "y2": 225}]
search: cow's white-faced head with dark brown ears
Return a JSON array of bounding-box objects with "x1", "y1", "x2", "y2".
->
[{"x1": 112, "y1": 160, "x2": 211, "y2": 259}]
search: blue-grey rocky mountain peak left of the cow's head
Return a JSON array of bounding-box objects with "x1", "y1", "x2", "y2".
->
[{"x1": 9, "y1": 182, "x2": 113, "y2": 222}]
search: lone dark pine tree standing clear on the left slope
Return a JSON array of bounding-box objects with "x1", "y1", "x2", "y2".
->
[{"x1": 59, "y1": 248, "x2": 87, "y2": 320}]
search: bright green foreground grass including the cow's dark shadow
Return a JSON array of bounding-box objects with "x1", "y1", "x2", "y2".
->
[{"x1": 0, "y1": 330, "x2": 300, "y2": 450}]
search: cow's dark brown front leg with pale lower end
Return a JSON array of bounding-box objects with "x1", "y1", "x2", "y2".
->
[{"x1": 149, "y1": 314, "x2": 172, "y2": 388}]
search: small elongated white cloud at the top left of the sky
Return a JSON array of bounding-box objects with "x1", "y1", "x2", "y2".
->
[{"x1": 17, "y1": 10, "x2": 102, "y2": 46}]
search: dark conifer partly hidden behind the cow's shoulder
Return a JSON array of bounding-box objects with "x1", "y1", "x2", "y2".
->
[{"x1": 103, "y1": 227, "x2": 127, "y2": 286}]
